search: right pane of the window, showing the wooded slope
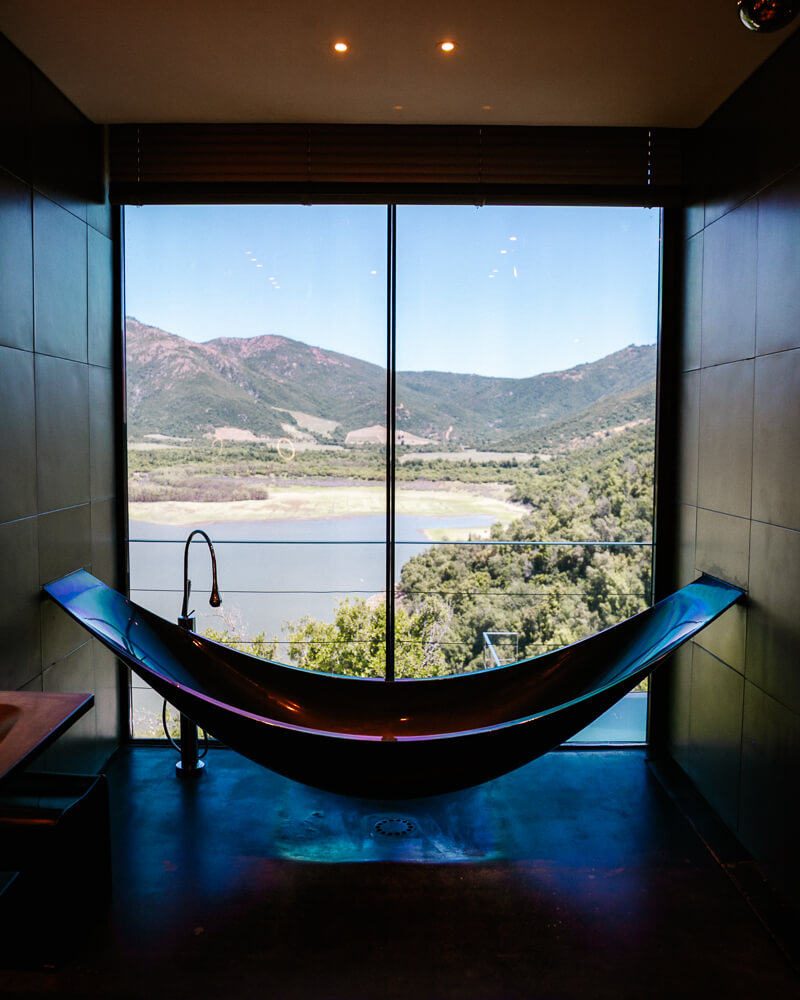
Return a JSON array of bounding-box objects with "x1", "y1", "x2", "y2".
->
[{"x1": 395, "y1": 206, "x2": 659, "y2": 741}]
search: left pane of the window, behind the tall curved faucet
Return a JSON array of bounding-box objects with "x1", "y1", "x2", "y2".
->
[{"x1": 125, "y1": 206, "x2": 387, "y2": 735}]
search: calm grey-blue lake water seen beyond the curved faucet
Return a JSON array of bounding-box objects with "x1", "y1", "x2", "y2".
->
[{"x1": 130, "y1": 514, "x2": 494, "y2": 636}]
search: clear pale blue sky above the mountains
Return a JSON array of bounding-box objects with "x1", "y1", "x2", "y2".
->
[{"x1": 125, "y1": 205, "x2": 659, "y2": 377}]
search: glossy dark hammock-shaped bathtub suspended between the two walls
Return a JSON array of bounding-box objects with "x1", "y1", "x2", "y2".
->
[{"x1": 44, "y1": 570, "x2": 742, "y2": 799}]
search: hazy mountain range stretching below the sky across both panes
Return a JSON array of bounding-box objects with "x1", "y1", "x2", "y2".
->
[{"x1": 126, "y1": 318, "x2": 656, "y2": 446}]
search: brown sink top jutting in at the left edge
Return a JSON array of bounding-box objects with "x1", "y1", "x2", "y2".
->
[{"x1": 0, "y1": 691, "x2": 94, "y2": 781}]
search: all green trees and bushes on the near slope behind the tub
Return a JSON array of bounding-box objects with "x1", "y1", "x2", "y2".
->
[{"x1": 282, "y1": 423, "x2": 653, "y2": 677}]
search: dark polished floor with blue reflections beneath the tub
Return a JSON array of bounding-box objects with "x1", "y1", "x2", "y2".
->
[{"x1": 0, "y1": 748, "x2": 800, "y2": 1000}]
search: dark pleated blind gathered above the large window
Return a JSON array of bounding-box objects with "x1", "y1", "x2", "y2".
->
[{"x1": 104, "y1": 125, "x2": 681, "y2": 205}]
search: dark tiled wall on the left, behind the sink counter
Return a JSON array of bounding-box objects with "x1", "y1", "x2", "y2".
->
[{"x1": 0, "y1": 29, "x2": 120, "y2": 772}]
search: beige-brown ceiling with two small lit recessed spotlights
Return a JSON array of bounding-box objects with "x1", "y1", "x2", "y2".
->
[{"x1": 0, "y1": 0, "x2": 795, "y2": 127}]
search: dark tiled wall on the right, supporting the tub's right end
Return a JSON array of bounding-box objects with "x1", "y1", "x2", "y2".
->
[{"x1": 668, "y1": 32, "x2": 800, "y2": 905}]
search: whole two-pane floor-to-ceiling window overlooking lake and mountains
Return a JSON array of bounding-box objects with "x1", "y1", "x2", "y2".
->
[{"x1": 125, "y1": 199, "x2": 659, "y2": 742}]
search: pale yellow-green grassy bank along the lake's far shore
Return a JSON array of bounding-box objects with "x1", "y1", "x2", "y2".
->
[{"x1": 129, "y1": 484, "x2": 524, "y2": 537}]
